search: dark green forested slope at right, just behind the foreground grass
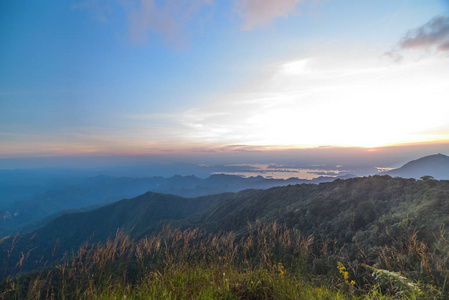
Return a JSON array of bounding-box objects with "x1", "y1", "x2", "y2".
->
[{"x1": 191, "y1": 176, "x2": 449, "y2": 245}]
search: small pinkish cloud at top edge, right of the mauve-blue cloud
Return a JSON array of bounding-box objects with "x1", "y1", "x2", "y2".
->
[{"x1": 234, "y1": 0, "x2": 305, "y2": 30}]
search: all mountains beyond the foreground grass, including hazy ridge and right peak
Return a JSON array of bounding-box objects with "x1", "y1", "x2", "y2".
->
[{"x1": 0, "y1": 154, "x2": 449, "y2": 276}]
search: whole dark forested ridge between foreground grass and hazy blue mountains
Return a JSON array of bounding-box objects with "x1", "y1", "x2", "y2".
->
[{"x1": 0, "y1": 176, "x2": 449, "y2": 278}]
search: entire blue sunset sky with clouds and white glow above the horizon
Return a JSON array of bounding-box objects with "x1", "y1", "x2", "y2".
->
[{"x1": 0, "y1": 0, "x2": 449, "y2": 166}]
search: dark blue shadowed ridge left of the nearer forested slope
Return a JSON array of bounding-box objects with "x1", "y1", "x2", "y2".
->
[{"x1": 0, "y1": 192, "x2": 233, "y2": 278}]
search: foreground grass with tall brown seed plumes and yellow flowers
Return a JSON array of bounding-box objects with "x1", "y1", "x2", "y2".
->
[{"x1": 0, "y1": 221, "x2": 449, "y2": 299}]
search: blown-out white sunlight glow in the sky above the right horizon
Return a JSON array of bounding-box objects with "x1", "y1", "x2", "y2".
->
[{"x1": 180, "y1": 53, "x2": 449, "y2": 147}]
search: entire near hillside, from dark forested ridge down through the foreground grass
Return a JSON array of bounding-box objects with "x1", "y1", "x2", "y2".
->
[{"x1": 1, "y1": 176, "x2": 449, "y2": 299}]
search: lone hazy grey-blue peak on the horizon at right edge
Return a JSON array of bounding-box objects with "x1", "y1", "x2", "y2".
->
[{"x1": 387, "y1": 153, "x2": 449, "y2": 180}]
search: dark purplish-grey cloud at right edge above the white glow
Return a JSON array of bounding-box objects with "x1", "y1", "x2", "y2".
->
[{"x1": 399, "y1": 15, "x2": 449, "y2": 52}]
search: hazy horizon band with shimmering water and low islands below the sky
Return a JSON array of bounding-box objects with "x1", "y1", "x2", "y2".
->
[{"x1": 0, "y1": 145, "x2": 447, "y2": 180}]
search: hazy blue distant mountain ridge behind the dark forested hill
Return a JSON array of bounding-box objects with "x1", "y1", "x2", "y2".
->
[{"x1": 0, "y1": 171, "x2": 344, "y2": 237}]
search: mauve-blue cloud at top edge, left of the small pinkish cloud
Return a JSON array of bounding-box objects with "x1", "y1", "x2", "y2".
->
[{"x1": 120, "y1": 0, "x2": 213, "y2": 45}]
